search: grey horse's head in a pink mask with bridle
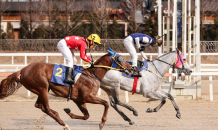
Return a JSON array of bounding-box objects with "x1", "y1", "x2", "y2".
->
[{"x1": 174, "y1": 50, "x2": 192, "y2": 75}]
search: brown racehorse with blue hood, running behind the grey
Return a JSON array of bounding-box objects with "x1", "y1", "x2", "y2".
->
[{"x1": 0, "y1": 50, "x2": 133, "y2": 130}]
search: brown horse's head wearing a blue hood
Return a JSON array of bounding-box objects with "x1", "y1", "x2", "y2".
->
[{"x1": 107, "y1": 47, "x2": 133, "y2": 75}]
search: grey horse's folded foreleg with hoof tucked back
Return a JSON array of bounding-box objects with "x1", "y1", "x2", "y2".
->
[{"x1": 146, "y1": 92, "x2": 166, "y2": 113}]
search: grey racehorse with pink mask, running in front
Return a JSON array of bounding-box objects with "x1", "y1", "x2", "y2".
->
[{"x1": 100, "y1": 50, "x2": 192, "y2": 125}]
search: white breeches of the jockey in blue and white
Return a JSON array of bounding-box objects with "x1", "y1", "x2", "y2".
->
[{"x1": 123, "y1": 36, "x2": 138, "y2": 66}]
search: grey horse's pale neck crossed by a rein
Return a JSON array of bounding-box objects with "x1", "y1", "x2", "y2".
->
[{"x1": 154, "y1": 52, "x2": 176, "y2": 75}]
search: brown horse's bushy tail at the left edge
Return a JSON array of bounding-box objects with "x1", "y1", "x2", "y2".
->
[{"x1": 0, "y1": 70, "x2": 22, "y2": 99}]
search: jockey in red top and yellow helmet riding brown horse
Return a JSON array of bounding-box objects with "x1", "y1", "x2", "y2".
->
[{"x1": 57, "y1": 34, "x2": 101, "y2": 84}]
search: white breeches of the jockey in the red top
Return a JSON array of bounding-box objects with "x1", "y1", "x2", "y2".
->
[{"x1": 57, "y1": 39, "x2": 77, "y2": 67}]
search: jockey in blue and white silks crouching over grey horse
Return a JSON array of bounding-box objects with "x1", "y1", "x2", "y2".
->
[{"x1": 124, "y1": 33, "x2": 163, "y2": 77}]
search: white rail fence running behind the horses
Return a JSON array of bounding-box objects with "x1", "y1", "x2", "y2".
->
[{"x1": 0, "y1": 53, "x2": 218, "y2": 102}]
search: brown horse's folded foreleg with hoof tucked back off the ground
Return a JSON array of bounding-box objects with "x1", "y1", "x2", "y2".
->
[{"x1": 64, "y1": 102, "x2": 89, "y2": 120}]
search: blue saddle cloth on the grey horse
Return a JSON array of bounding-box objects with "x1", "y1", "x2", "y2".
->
[{"x1": 122, "y1": 60, "x2": 148, "y2": 79}]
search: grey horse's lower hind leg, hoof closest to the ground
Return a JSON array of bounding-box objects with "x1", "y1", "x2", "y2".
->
[{"x1": 109, "y1": 97, "x2": 135, "y2": 125}]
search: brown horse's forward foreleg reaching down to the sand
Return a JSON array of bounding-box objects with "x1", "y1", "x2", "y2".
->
[{"x1": 86, "y1": 95, "x2": 109, "y2": 130}]
